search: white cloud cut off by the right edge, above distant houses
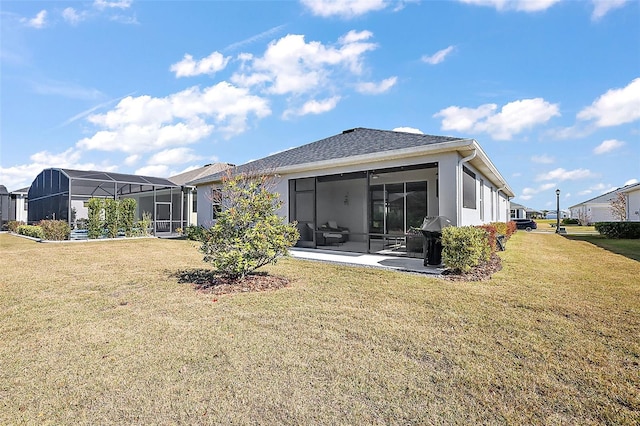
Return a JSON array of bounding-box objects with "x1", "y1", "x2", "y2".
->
[{"x1": 577, "y1": 78, "x2": 640, "y2": 127}]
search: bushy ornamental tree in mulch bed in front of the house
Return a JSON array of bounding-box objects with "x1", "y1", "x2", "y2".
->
[{"x1": 200, "y1": 170, "x2": 300, "y2": 280}]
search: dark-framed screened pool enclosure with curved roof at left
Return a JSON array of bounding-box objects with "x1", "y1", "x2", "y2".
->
[{"x1": 28, "y1": 168, "x2": 193, "y2": 235}]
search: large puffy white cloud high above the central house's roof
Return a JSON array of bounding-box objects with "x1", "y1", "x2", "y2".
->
[{"x1": 231, "y1": 31, "x2": 377, "y2": 95}]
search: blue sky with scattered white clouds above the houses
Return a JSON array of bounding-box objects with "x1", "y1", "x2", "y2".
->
[{"x1": 0, "y1": 0, "x2": 640, "y2": 209}]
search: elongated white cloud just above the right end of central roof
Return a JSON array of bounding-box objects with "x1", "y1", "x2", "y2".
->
[{"x1": 433, "y1": 98, "x2": 560, "y2": 140}]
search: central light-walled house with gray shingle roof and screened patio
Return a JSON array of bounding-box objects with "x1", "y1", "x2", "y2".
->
[{"x1": 189, "y1": 128, "x2": 514, "y2": 253}]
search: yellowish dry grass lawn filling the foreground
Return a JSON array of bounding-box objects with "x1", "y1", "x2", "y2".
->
[{"x1": 0, "y1": 232, "x2": 640, "y2": 425}]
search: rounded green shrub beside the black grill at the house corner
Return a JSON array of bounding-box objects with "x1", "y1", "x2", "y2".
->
[{"x1": 442, "y1": 226, "x2": 491, "y2": 273}]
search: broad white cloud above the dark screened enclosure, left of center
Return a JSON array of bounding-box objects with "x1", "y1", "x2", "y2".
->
[{"x1": 77, "y1": 82, "x2": 271, "y2": 153}]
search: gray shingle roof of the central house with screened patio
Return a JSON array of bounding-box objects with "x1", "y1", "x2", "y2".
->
[{"x1": 189, "y1": 127, "x2": 462, "y2": 184}]
